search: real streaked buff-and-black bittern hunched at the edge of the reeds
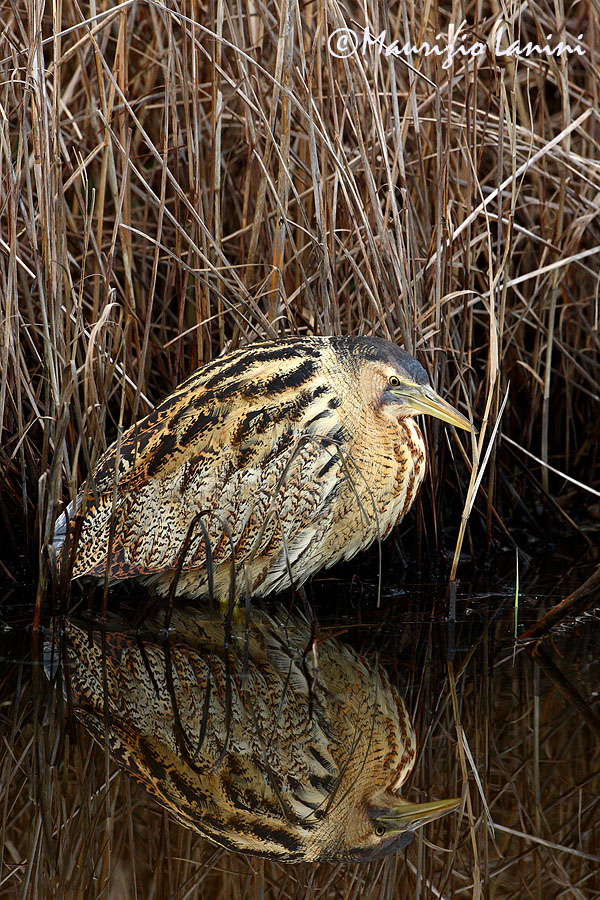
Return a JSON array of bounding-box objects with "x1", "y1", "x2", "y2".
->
[{"x1": 54, "y1": 337, "x2": 470, "y2": 597}]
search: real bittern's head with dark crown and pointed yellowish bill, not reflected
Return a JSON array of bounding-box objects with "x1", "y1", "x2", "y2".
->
[{"x1": 346, "y1": 337, "x2": 473, "y2": 431}]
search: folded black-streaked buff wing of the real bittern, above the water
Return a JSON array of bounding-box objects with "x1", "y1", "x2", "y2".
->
[{"x1": 61, "y1": 339, "x2": 351, "y2": 580}]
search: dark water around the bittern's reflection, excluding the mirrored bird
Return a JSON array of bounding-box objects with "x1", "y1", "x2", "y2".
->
[{"x1": 0, "y1": 548, "x2": 600, "y2": 900}]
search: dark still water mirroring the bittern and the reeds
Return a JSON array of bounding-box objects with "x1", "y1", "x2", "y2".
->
[{"x1": 0, "y1": 550, "x2": 600, "y2": 900}]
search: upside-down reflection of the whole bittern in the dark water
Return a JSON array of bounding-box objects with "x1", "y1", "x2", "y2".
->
[{"x1": 54, "y1": 611, "x2": 459, "y2": 861}]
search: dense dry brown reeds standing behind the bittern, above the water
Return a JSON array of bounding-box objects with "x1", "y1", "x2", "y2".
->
[{"x1": 0, "y1": 0, "x2": 600, "y2": 596}]
